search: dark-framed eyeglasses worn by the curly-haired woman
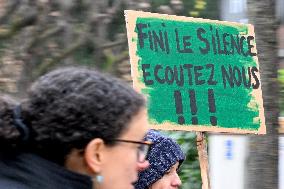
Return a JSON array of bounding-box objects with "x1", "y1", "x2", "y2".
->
[{"x1": 108, "y1": 139, "x2": 153, "y2": 163}]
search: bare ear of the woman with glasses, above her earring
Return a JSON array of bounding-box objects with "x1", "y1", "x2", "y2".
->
[{"x1": 84, "y1": 138, "x2": 105, "y2": 173}]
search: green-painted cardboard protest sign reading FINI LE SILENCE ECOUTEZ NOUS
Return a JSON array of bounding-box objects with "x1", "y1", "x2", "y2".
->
[{"x1": 125, "y1": 11, "x2": 266, "y2": 134}]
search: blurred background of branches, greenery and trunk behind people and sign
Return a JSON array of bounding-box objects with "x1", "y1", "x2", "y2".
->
[{"x1": 0, "y1": 0, "x2": 284, "y2": 189}]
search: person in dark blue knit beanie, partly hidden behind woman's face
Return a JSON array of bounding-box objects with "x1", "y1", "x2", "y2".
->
[{"x1": 134, "y1": 130, "x2": 185, "y2": 189}]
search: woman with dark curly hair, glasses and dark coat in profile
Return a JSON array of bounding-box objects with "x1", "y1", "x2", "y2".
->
[{"x1": 0, "y1": 67, "x2": 150, "y2": 189}]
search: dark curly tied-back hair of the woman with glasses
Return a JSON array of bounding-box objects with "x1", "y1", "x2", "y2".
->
[{"x1": 0, "y1": 67, "x2": 145, "y2": 164}]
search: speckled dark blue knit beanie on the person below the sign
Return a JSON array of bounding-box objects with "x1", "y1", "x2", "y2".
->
[{"x1": 135, "y1": 130, "x2": 185, "y2": 189}]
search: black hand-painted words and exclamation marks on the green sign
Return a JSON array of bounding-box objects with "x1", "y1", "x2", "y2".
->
[{"x1": 136, "y1": 22, "x2": 260, "y2": 125}]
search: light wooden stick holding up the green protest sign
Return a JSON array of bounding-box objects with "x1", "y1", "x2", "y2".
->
[{"x1": 196, "y1": 132, "x2": 210, "y2": 189}]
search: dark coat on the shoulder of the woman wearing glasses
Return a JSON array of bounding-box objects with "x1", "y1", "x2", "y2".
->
[{"x1": 0, "y1": 153, "x2": 92, "y2": 189}]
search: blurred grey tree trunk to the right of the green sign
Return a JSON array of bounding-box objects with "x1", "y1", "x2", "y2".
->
[{"x1": 246, "y1": 0, "x2": 279, "y2": 189}]
